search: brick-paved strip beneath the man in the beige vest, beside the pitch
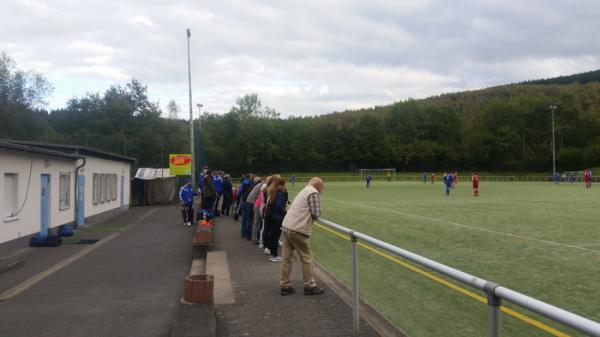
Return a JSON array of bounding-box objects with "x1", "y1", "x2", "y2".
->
[{"x1": 213, "y1": 217, "x2": 377, "y2": 337}]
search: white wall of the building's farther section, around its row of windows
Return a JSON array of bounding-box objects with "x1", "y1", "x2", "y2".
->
[{"x1": 79, "y1": 156, "x2": 131, "y2": 218}]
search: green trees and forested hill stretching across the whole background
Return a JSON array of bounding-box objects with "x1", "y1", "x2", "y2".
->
[{"x1": 0, "y1": 49, "x2": 600, "y2": 174}]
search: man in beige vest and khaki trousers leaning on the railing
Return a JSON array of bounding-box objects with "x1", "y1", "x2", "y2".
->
[{"x1": 280, "y1": 177, "x2": 324, "y2": 296}]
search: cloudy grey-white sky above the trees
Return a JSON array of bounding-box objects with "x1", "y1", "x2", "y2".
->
[{"x1": 0, "y1": 0, "x2": 600, "y2": 117}]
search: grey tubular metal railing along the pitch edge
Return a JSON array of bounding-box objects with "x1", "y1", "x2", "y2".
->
[{"x1": 317, "y1": 218, "x2": 600, "y2": 337}]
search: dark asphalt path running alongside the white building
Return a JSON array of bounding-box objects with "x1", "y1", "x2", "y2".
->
[{"x1": 0, "y1": 206, "x2": 209, "y2": 337}]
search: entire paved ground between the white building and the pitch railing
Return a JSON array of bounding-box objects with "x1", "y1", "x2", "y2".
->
[{"x1": 0, "y1": 206, "x2": 376, "y2": 337}]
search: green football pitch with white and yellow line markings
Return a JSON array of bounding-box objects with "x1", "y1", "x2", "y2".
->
[{"x1": 290, "y1": 181, "x2": 600, "y2": 337}]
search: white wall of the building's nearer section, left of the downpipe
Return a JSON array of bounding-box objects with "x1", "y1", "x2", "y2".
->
[{"x1": 0, "y1": 149, "x2": 75, "y2": 243}]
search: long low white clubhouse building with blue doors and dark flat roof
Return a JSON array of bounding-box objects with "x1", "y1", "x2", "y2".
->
[{"x1": 0, "y1": 140, "x2": 135, "y2": 244}]
